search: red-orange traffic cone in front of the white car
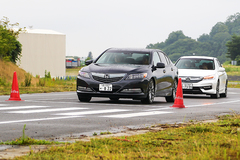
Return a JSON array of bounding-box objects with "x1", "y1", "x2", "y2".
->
[{"x1": 171, "y1": 78, "x2": 185, "y2": 108}]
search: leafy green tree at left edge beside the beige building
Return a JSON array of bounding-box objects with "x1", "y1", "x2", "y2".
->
[{"x1": 0, "y1": 17, "x2": 22, "y2": 63}]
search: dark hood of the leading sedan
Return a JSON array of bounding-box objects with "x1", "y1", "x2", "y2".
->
[{"x1": 83, "y1": 64, "x2": 150, "y2": 73}]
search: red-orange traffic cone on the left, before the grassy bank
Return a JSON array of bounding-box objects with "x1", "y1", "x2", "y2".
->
[{"x1": 8, "y1": 72, "x2": 21, "y2": 101}]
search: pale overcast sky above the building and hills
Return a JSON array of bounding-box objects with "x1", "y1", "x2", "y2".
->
[{"x1": 0, "y1": 0, "x2": 240, "y2": 57}]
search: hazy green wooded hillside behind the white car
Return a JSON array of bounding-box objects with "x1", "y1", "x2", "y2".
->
[{"x1": 146, "y1": 13, "x2": 240, "y2": 63}]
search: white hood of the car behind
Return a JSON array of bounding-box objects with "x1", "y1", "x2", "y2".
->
[{"x1": 178, "y1": 69, "x2": 215, "y2": 77}]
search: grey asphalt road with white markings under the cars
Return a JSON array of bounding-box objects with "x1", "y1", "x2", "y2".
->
[{"x1": 0, "y1": 88, "x2": 240, "y2": 141}]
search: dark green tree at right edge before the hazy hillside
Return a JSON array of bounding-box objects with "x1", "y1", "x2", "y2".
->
[{"x1": 226, "y1": 34, "x2": 240, "y2": 60}]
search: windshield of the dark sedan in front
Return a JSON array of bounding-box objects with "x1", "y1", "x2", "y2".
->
[{"x1": 95, "y1": 50, "x2": 150, "y2": 65}]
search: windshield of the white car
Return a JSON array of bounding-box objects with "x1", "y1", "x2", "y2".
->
[{"x1": 176, "y1": 58, "x2": 215, "y2": 70}]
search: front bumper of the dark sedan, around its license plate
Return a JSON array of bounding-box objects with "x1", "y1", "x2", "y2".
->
[{"x1": 77, "y1": 76, "x2": 149, "y2": 99}]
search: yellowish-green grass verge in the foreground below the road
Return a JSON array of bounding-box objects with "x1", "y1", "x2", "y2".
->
[{"x1": 15, "y1": 115, "x2": 240, "y2": 160}]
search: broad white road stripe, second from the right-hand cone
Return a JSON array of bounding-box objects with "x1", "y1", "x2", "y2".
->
[{"x1": 53, "y1": 109, "x2": 131, "y2": 116}]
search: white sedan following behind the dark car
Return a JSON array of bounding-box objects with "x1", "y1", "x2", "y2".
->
[{"x1": 175, "y1": 56, "x2": 228, "y2": 98}]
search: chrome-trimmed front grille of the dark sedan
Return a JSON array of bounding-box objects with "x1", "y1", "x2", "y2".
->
[{"x1": 92, "y1": 73, "x2": 125, "y2": 83}]
